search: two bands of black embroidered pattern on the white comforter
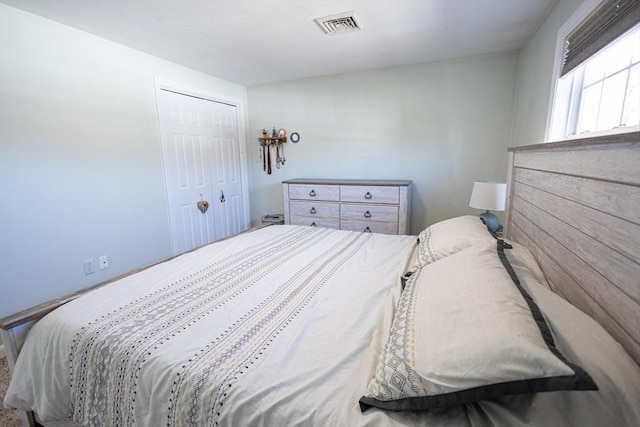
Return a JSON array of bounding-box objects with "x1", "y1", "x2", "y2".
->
[{"x1": 69, "y1": 228, "x2": 371, "y2": 426}]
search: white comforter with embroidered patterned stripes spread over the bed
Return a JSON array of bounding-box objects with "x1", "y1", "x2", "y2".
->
[{"x1": 5, "y1": 226, "x2": 466, "y2": 426}]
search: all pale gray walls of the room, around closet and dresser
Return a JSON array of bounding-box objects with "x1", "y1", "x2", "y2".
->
[{"x1": 0, "y1": 0, "x2": 581, "y2": 316}]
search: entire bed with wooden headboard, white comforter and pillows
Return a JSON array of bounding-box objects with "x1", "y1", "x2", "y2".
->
[{"x1": 0, "y1": 133, "x2": 640, "y2": 426}]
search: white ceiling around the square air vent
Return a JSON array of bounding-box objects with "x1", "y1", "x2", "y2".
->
[{"x1": 0, "y1": 0, "x2": 556, "y2": 86}]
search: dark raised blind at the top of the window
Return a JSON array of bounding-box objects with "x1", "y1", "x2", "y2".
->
[{"x1": 560, "y1": 0, "x2": 640, "y2": 76}]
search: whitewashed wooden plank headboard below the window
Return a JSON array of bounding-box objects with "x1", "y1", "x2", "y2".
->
[{"x1": 505, "y1": 132, "x2": 640, "y2": 364}]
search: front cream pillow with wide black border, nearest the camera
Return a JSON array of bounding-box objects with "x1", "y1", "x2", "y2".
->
[{"x1": 360, "y1": 240, "x2": 597, "y2": 411}]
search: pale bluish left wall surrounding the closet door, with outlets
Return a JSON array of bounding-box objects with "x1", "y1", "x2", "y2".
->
[{"x1": 0, "y1": 4, "x2": 246, "y2": 316}]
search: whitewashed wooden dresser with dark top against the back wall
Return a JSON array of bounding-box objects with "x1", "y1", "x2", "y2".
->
[{"x1": 282, "y1": 178, "x2": 411, "y2": 234}]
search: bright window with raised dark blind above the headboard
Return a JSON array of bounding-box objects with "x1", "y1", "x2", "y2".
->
[{"x1": 547, "y1": 0, "x2": 640, "y2": 140}]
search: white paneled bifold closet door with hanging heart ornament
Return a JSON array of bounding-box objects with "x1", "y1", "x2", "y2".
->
[{"x1": 158, "y1": 89, "x2": 245, "y2": 255}]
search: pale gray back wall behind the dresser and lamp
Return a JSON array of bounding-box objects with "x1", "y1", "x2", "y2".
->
[{"x1": 248, "y1": 53, "x2": 518, "y2": 234}]
